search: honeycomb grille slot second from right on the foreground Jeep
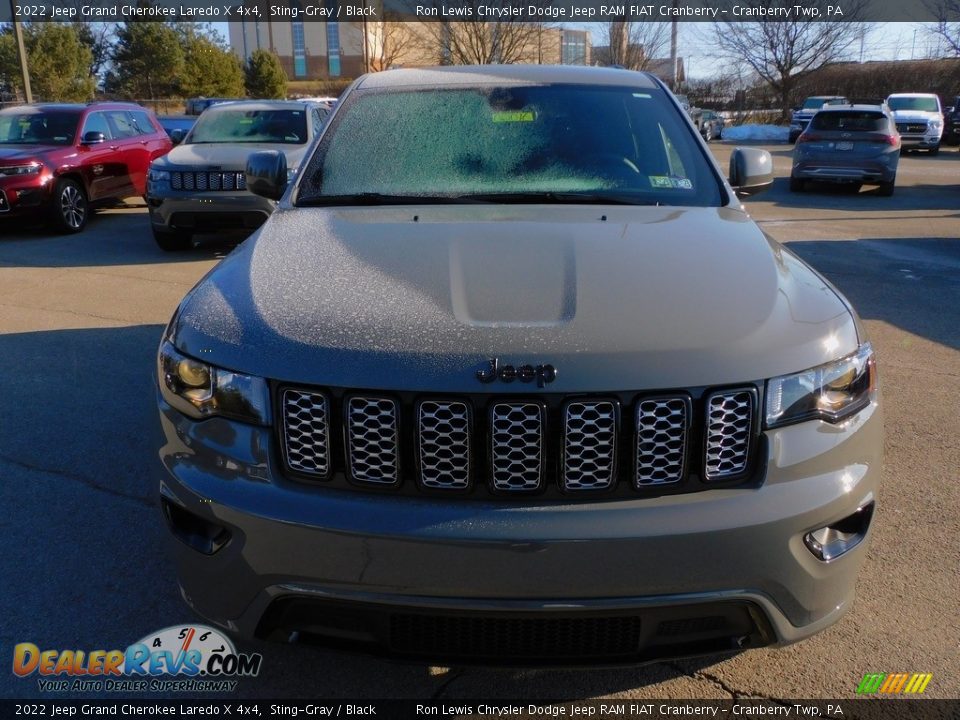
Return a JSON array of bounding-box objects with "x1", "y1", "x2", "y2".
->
[{"x1": 633, "y1": 397, "x2": 691, "y2": 488}]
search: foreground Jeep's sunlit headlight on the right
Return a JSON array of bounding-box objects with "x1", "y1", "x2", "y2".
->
[{"x1": 766, "y1": 343, "x2": 877, "y2": 428}]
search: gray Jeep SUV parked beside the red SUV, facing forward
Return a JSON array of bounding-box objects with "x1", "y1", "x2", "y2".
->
[{"x1": 147, "y1": 100, "x2": 328, "y2": 251}]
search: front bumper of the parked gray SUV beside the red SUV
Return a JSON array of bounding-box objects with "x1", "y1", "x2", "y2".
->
[{"x1": 147, "y1": 183, "x2": 276, "y2": 232}]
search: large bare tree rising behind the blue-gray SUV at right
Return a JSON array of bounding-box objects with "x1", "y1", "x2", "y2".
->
[{"x1": 714, "y1": 0, "x2": 865, "y2": 119}]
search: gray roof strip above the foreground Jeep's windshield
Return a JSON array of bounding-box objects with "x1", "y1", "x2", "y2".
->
[{"x1": 358, "y1": 65, "x2": 658, "y2": 90}]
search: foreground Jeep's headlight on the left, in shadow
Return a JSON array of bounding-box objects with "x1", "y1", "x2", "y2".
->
[{"x1": 157, "y1": 340, "x2": 270, "y2": 425}]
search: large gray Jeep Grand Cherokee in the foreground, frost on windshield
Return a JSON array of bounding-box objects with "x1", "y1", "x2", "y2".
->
[{"x1": 157, "y1": 65, "x2": 882, "y2": 665}]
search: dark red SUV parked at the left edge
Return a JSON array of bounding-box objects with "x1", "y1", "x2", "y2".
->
[{"x1": 0, "y1": 102, "x2": 173, "y2": 233}]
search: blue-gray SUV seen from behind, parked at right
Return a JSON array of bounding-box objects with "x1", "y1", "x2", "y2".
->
[{"x1": 790, "y1": 105, "x2": 900, "y2": 196}]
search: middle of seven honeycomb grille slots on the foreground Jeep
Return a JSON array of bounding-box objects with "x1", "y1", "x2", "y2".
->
[{"x1": 490, "y1": 402, "x2": 546, "y2": 492}]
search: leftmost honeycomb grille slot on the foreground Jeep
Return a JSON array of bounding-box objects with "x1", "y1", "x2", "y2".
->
[{"x1": 281, "y1": 389, "x2": 331, "y2": 478}]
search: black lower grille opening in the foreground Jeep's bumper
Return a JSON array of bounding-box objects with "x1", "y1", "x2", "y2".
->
[{"x1": 256, "y1": 597, "x2": 775, "y2": 666}]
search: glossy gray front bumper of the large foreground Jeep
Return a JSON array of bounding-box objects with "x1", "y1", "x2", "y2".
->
[{"x1": 159, "y1": 399, "x2": 883, "y2": 663}]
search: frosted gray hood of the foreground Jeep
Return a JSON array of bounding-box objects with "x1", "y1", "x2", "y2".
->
[{"x1": 171, "y1": 205, "x2": 857, "y2": 393}]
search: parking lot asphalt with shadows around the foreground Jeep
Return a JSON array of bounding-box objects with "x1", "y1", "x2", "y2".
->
[{"x1": 0, "y1": 143, "x2": 960, "y2": 700}]
